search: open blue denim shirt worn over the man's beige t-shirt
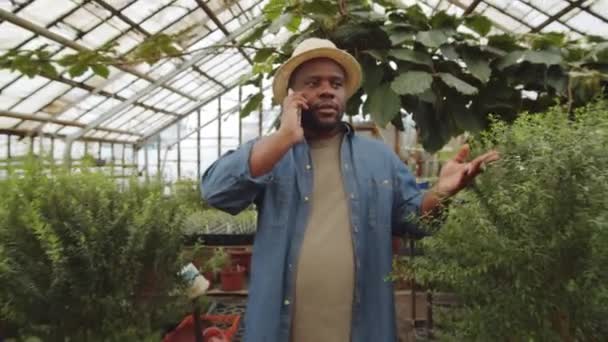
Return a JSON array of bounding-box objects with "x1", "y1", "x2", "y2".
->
[{"x1": 202, "y1": 125, "x2": 422, "y2": 342}]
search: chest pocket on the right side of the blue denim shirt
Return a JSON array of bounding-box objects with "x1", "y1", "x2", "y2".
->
[{"x1": 367, "y1": 177, "x2": 393, "y2": 230}]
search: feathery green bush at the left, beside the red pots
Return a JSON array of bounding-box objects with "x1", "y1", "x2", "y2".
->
[{"x1": 0, "y1": 161, "x2": 188, "y2": 341}]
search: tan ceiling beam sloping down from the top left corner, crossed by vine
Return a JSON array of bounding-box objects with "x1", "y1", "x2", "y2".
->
[{"x1": 0, "y1": 9, "x2": 197, "y2": 101}]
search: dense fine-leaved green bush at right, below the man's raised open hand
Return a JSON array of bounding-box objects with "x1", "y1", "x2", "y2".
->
[{"x1": 410, "y1": 101, "x2": 608, "y2": 341}]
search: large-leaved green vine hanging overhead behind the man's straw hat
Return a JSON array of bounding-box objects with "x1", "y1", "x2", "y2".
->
[{"x1": 241, "y1": 0, "x2": 608, "y2": 151}]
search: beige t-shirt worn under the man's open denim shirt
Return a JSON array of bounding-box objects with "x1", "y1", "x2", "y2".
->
[{"x1": 292, "y1": 134, "x2": 355, "y2": 342}]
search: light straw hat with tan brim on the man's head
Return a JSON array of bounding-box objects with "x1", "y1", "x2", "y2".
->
[{"x1": 272, "y1": 38, "x2": 361, "y2": 103}]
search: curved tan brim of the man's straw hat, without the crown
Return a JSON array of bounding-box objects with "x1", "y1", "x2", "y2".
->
[{"x1": 272, "y1": 48, "x2": 361, "y2": 103}]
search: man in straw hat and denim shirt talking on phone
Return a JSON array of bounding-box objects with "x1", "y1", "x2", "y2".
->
[{"x1": 202, "y1": 38, "x2": 497, "y2": 342}]
